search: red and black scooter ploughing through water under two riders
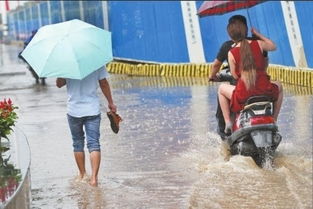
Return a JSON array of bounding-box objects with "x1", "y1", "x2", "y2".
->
[{"x1": 217, "y1": 68, "x2": 282, "y2": 167}]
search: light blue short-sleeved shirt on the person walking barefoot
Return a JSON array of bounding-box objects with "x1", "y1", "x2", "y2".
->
[{"x1": 66, "y1": 67, "x2": 109, "y2": 117}]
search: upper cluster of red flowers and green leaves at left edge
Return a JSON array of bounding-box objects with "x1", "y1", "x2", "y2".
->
[{"x1": 0, "y1": 99, "x2": 18, "y2": 139}]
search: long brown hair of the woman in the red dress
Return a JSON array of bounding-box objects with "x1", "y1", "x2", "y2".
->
[{"x1": 227, "y1": 20, "x2": 256, "y2": 90}]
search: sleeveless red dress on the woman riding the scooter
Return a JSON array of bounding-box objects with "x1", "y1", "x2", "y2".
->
[{"x1": 230, "y1": 40, "x2": 279, "y2": 113}]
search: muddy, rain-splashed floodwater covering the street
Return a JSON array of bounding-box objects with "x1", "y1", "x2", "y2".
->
[{"x1": 0, "y1": 44, "x2": 313, "y2": 209}]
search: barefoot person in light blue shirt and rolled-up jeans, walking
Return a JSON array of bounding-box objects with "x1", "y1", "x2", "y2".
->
[{"x1": 56, "y1": 67, "x2": 117, "y2": 186}]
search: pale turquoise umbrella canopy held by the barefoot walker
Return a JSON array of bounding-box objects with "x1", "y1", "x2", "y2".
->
[{"x1": 21, "y1": 19, "x2": 113, "y2": 79}]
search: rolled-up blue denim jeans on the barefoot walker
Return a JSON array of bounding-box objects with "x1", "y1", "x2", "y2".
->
[{"x1": 67, "y1": 114, "x2": 101, "y2": 152}]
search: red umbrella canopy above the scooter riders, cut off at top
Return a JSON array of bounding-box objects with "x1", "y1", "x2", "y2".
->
[{"x1": 198, "y1": 0, "x2": 264, "y2": 17}]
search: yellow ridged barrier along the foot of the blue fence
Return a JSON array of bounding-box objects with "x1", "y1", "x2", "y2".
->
[{"x1": 107, "y1": 61, "x2": 313, "y2": 88}]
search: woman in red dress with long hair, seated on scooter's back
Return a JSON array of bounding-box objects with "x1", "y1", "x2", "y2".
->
[{"x1": 218, "y1": 21, "x2": 283, "y2": 134}]
